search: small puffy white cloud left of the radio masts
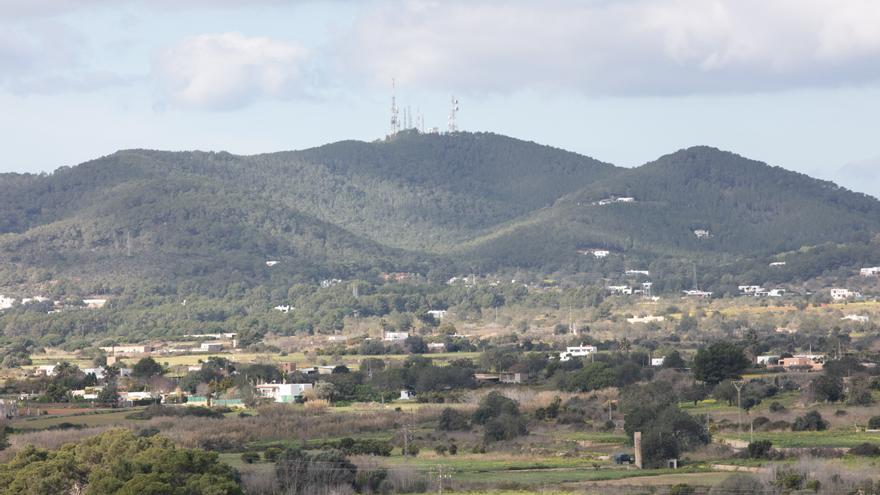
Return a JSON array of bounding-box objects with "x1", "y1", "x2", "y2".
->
[{"x1": 153, "y1": 33, "x2": 308, "y2": 110}]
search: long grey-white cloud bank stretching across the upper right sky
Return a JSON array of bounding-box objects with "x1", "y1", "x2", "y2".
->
[{"x1": 336, "y1": 0, "x2": 880, "y2": 95}]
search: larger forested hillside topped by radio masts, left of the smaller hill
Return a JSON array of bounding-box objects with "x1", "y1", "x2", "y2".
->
[{"x1": 0, "y1": 134, "x2": 620, "y2": 289}]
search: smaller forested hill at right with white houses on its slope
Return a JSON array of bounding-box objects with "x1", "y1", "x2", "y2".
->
[{"x1": 463, "y1": 147, "x2": 880, "y2": 274}]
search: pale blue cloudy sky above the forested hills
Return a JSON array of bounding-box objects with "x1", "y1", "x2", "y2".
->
[{"x1": 0, "y1": 0, "x2": 880, "y2": 196}]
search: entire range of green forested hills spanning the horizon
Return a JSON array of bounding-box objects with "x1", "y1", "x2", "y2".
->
[{"x1": 0, "y1": 136, "x2": 880, "y2": 293}]
